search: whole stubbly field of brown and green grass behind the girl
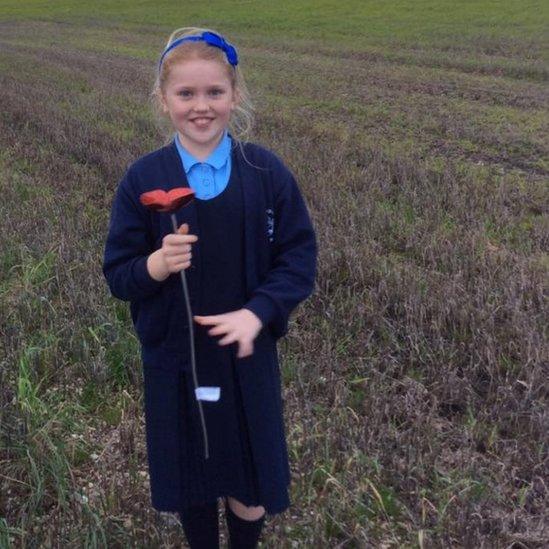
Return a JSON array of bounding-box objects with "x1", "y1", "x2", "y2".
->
[{"x1": 0, "y1": 0, "x2": 549, "y2": 548}]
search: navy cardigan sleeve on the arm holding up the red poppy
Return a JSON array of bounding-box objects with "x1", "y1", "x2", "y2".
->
[{"x1": 103, "y1": 168, "x2": 164, "y2": 301}]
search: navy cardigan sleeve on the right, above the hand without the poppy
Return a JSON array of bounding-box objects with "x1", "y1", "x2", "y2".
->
[{"x1": 244, "y1": 156, "x2": 318, "y2": 339}]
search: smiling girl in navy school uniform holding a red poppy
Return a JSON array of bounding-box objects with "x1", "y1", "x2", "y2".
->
[{"x1": 103, "y1": 28, "x2": 317, "y2": 548}]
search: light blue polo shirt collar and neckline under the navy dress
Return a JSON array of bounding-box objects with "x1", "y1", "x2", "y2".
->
[{"x1": 174, "y1": 130, "x2": 232, "y2": 200}]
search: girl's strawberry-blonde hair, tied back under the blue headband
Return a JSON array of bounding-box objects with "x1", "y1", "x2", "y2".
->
[{"x1": 151, "y1": 27, "x2": 254, "y2": 148}]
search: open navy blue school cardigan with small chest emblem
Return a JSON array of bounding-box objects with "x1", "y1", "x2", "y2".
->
[{"x1": 103, "y1": 137, "x2": 318, "y2": 369}]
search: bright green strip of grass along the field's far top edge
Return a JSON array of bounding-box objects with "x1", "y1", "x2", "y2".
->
[{"x1": 1, "y1": 0, "x2": 548, "y2": 51}]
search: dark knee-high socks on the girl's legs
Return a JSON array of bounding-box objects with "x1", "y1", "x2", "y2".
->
[{"x1": 179, "y1": 500, "x2": 265, "y2": 549}]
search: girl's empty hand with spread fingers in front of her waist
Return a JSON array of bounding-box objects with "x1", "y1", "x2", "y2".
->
[{"x1": 194, "y1": 309, "x2": 263, "y2": 358}]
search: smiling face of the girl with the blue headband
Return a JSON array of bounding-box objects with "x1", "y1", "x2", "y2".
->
[{"x1": 157, "y1": 59, "x2": 238, "y2": 160}]
